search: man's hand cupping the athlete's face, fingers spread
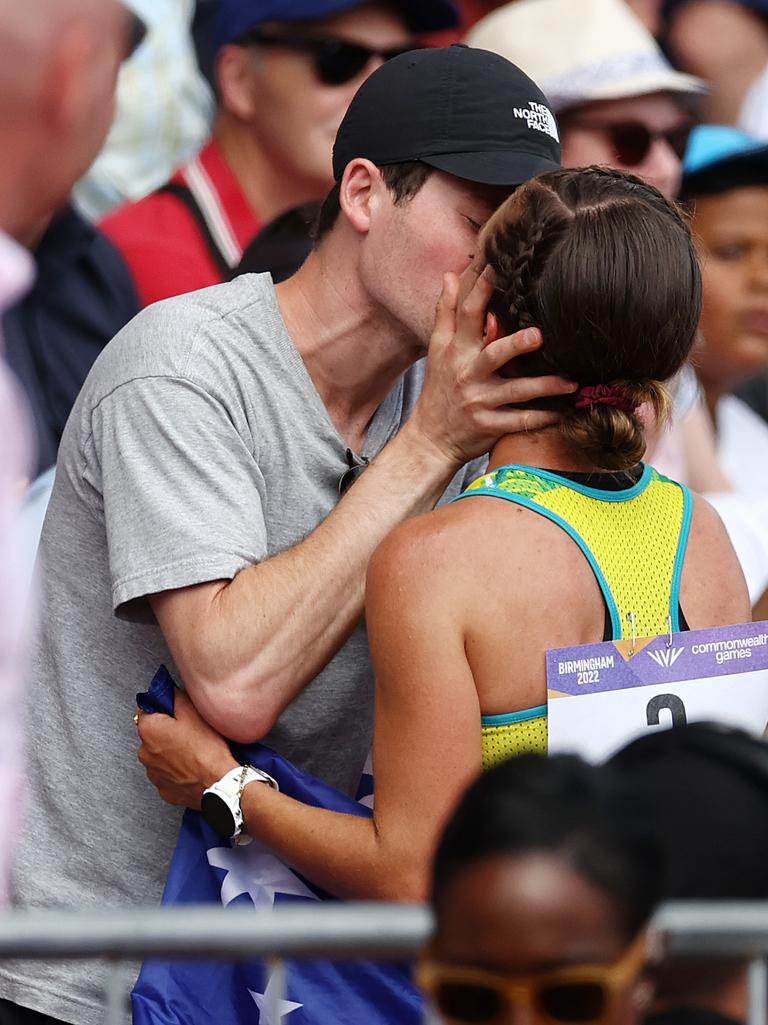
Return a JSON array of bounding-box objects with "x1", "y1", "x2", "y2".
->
[{"x1": 404, "y1": 268, "x2": 578, "y2": 466}]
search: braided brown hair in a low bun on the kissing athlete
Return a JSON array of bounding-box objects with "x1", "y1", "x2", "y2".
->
[{"x1": 481, "y1": 167, "x2": 701, "y2": 469}]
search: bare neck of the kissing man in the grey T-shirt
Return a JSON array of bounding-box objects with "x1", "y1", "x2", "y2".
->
[{"x1": 277, "y1": 238, "x2": 423, "y2": 452}]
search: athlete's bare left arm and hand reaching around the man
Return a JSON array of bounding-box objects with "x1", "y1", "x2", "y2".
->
[{"x1": 139, "y1": 513, "x2": 481, "y2": 901}]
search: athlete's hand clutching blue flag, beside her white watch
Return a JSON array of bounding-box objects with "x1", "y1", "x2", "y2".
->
[{"x1": 137, "y1": 691, "x2": 238, "y2": 808}]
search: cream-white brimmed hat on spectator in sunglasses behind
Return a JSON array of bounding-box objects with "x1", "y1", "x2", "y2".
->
[{"x1": 464, "y1": 0, "x2": 706, "y2": 111}]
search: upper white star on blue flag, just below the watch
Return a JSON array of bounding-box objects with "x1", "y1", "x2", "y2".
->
[{"x1": 208, "y1": 842, "x2": 318, "y2": 907}]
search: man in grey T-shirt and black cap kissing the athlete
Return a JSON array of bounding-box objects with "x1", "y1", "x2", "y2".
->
[{"x1": 0, "y1": 47, "x2": 561, "y2": 1025}]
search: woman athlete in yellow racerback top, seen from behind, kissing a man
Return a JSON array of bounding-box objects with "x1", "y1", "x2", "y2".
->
[{"x1": 139, "y1": 168, "x2": 749, "y2": 900}]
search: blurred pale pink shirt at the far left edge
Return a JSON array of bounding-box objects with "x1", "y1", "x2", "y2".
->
[{"x1": 0, "y1": 232, "x2": 33, "y2": 904}]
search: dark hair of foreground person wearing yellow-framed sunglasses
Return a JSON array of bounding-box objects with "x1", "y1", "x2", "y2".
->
[{"x1": 432, "y1": 754, "x2": 660, "y2": 937}]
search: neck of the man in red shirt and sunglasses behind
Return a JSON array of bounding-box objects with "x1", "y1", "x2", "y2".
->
[{"x1": 213, "y1": 112, "x2": 330, "y2": 224}]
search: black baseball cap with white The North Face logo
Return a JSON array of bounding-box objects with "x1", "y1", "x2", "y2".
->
[{"x1": 333, "y1": 44, "x2": 560, "y2": 186}]
